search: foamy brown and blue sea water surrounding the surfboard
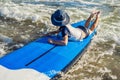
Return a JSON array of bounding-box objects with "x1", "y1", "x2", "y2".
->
[{"x1": 0, "y1": 0, "x2": 120, "y2": 80}]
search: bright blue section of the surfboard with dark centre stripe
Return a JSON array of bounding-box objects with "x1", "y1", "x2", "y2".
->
[{"x1": 0, "y1": 20, "x2": 96, "y2": 79}]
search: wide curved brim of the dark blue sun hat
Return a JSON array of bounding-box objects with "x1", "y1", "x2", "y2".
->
[{"x1": 51, "y1": 13, "x2": 70, "y2": 26}]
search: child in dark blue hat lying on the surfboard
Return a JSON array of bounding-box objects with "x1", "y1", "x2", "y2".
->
[{"x1": 46, "y1": 10, "x2": 100, "y2": 45}]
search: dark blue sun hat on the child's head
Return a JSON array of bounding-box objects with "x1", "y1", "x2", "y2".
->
[{"x1": 51, "y1": 9, "x2": 70, "y2": 26}]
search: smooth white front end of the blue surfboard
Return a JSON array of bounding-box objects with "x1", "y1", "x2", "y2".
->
[{"x1": 0, "y1": 65, "x2": 50, "y2": 80}]
